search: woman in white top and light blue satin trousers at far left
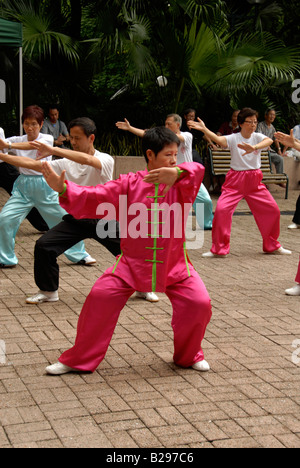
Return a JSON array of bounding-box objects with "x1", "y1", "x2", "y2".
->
[{"x1": 0, "y1": 106, "x2": 90, "y2": 268}]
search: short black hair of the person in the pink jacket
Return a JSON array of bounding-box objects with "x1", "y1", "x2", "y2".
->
[{"x1": 142, "y1": 127, "x2": 180, "y2": 163}]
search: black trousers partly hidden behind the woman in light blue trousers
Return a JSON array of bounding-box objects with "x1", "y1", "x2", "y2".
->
[{"x1": 0, "y1": 163, "x2": 49, "y2": 232}]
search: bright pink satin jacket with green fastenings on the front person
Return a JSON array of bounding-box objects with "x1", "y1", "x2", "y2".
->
[{"x1": 59, "y1": 163, "x2": 205, "y2": 292}]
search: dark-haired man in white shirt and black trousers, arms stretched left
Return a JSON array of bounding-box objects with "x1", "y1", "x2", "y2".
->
[{"x1": 0, "y1": 117, "x2": 158, "y2": 304}]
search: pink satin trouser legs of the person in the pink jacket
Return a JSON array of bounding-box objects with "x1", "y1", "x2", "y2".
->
[{"x1": 59, "y1": 268, "x2": 212, "y2": 372}]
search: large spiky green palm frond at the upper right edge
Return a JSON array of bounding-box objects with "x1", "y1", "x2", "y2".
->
[{"x1": 206, "y1": 32, "x2": 300, "y2": 100}]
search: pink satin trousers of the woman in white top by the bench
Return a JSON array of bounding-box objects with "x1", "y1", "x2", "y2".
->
[{"x1": 211, "y1": 169, "x2": 281, "y2": 255}]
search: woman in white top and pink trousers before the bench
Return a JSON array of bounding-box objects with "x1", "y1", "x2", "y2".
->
[{"x1": 189, "y1": 107, "x2": 291, "y2": 258}]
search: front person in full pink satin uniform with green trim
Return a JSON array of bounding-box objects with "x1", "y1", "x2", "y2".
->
[{"x1": 43, "y1": 127, "x2": 211, "y2": 375}]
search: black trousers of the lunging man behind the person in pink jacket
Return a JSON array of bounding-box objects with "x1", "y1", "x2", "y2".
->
[{"x1": 34, "y1": 215, "x2": 121, "y2": 292}]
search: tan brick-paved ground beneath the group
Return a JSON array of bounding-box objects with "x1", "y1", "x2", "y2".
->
[{"x1": 0, "y1": 188, "x2": 300, "y2": 449}]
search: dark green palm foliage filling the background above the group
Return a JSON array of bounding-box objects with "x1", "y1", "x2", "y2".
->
[{"x1": 0, "y1": 0, "x2": 300, "y2": 150}]
